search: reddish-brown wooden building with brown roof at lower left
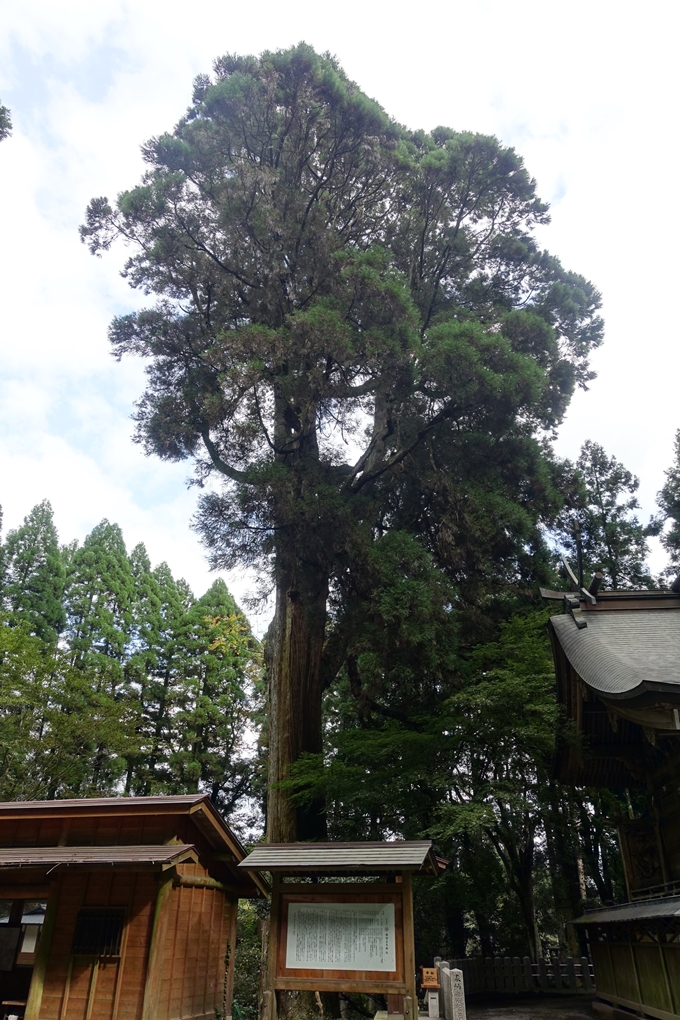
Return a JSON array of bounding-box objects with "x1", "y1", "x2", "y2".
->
[{"x1": 0, "y1": 795, "x2": 268, "y2": 1020}]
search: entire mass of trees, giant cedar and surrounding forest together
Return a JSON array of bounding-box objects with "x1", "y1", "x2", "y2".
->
[{"x1": 0, "y1": 44, "x2": 680, "y2": 979}]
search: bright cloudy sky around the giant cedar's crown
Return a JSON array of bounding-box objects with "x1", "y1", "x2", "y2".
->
[{"x1": 0, "y1": 0, "x2": 680, "y2": 628}]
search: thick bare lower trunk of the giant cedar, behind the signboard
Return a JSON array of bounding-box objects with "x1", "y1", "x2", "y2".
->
[{"x1": 267, "y1": 539, "x2": 328, "y2": 843}]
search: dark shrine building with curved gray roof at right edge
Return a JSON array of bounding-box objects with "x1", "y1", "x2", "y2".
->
[{"x1": 543, "y1": 584, "x2": 680, "y2": 1020}]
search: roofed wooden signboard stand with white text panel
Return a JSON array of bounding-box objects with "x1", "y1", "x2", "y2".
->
[{"x1": 240, "y1": 840, "x2": 446, "y2": 1020}]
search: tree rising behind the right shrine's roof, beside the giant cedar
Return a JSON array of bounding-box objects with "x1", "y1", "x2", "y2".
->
[{"x1": 557, "y1": 440, "x2": 656, "y2": 589}]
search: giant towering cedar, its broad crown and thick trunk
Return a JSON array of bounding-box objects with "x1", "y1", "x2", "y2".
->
[{"x1": 82, "y1": 44, "x2": 601, "y2": 839}]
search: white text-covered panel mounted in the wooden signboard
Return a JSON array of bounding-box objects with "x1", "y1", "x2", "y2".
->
[{"x1": 285, "y1": 903, "x2": 397, "y2": 971}]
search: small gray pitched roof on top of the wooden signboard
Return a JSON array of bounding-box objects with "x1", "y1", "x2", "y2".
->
[{"x1": 239, "y1": 839, "x2": 447, "y2": 875}]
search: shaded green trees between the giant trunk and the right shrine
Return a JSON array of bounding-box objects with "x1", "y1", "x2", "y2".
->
[{"x1": 290, "y1": 607, "x2": 621, "y2": 959}]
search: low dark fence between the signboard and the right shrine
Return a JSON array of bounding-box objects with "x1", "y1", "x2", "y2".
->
[{"x1": 434, "y1": 957, "x2": 595, "y2": 995}]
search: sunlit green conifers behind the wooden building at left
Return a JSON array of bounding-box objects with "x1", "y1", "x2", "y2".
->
[{"x1": 0, "y1": 502, "x2": 260, "y2": 812}]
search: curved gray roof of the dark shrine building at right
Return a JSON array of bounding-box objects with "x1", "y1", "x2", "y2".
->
[{"x1": 551, "y1": 610, "x2": 680, "y2": 698}]
